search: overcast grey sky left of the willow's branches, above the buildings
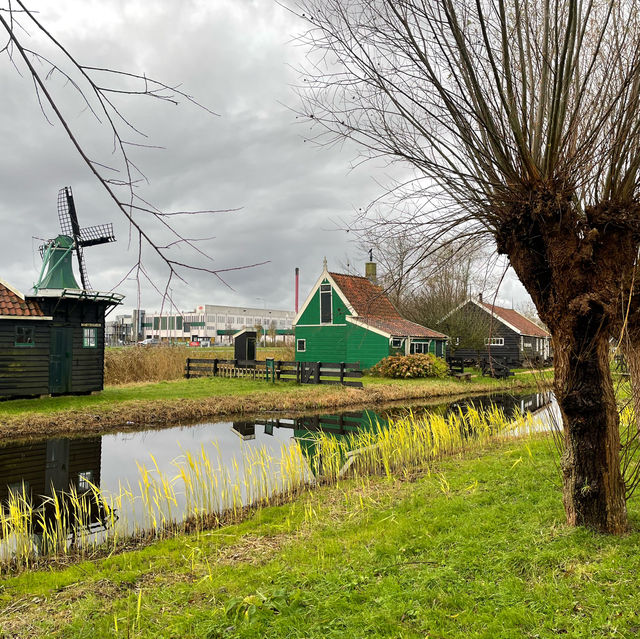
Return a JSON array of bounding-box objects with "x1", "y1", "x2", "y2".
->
[{"x1": 0, "y1": 0, "x2": 526, "y2": 311}]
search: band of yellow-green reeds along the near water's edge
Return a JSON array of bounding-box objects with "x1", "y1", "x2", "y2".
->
[{"x1": 0, "y1": 407, "x2": 531, "y2": 571}]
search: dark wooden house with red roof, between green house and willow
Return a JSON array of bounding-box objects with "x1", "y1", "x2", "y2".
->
[{"x1": 439, "y1": 296, "x2": 551, "y2": 367}]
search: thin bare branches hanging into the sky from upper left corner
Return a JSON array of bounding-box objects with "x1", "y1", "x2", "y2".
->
[{"x1": 0, "y1": 0, "x2": 260, "y2": 297}]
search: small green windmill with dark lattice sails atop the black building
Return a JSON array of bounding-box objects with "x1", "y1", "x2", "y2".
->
[{"x1": 34, "y1": 186, "x2": 116, "y2": 291}]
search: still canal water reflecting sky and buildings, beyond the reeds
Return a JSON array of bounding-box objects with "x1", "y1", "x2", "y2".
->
[{"x1": 0, "y1": 393, "x2": 553, "y2": 526}]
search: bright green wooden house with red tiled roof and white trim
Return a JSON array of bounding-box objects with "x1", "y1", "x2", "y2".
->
[{"x1": 294, "y1": 262, "x2": 447, "y2": 369}]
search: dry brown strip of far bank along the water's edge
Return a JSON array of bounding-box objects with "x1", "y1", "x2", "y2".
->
[{"x1": 0, "y1": 380, "x2": 540, "y2": 441}]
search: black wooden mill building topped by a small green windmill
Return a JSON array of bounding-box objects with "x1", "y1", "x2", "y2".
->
[{"x1": 0, "y1": 187, "x2": 123, "y2": 399}]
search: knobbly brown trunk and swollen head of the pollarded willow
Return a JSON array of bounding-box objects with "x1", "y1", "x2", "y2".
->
[{"x1": 497, "y1": 191, "x2": 636, "y2": 534}]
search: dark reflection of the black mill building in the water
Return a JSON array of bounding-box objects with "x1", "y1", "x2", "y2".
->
[{"x1": 0, "y1": 437, "x2": 105, "y2": 537}]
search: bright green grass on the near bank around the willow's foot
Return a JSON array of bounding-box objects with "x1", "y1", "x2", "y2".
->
[{"x1": 0, "y1": 439, "x2": 640, "y2": 639}]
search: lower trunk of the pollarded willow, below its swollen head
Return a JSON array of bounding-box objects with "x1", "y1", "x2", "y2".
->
[{"x1": 554, "y1": 312, "x2": 627, "y2": 534}]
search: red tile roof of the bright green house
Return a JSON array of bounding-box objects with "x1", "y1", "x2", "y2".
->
[{"x1": 329, "y1": 273, "x2": 446, "y2": 339}]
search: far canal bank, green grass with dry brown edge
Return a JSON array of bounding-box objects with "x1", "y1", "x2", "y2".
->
[{"x1": 0, "y1": 373, "x2": 544, "y2": 439}]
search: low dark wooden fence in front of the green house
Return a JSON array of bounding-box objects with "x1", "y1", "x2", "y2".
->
[{"x1": 184, "y1": 357, "x2": 362, "y2": 388}]
